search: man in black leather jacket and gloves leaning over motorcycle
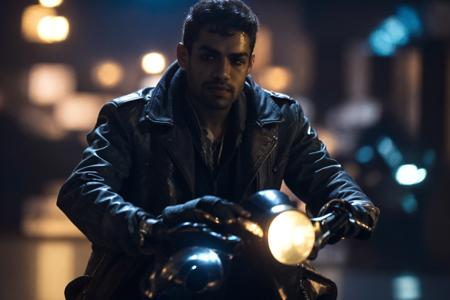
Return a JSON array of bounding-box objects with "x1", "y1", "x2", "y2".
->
[{"x1": 58, "y1": 0, "x2": 378, "y2": 299}]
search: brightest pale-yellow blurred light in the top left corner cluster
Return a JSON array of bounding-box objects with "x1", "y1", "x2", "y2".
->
[{"x1": 37, "y1": 16, "x2": 70, "y2": 43}]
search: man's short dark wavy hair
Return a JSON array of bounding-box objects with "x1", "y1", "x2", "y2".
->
[{"x1": 183, "y1": 0, "x2": 259, "y2": 53}]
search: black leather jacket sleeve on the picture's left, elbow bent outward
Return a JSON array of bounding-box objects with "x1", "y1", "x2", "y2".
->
[{"x1": 57, "y1": 102, "x2": 149, "y2": 254}]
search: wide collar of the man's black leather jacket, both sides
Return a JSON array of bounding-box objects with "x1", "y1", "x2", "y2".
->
[{"x1": 144, "y1": 61, "x2": 283, "y2": 127}]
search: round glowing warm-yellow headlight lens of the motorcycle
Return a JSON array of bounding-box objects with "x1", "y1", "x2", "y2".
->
[{"x1": 268, "y1": 210, "x2": 315, "y2": 265}]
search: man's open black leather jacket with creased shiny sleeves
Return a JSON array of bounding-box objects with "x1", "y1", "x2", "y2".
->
[{"x1": 57, "y1": 63, "x2": 378, "y2": 299}]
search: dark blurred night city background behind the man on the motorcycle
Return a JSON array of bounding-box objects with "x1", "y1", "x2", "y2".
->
[{"x1": 0, "y1": 0, "x2": 450, "y2": 300}]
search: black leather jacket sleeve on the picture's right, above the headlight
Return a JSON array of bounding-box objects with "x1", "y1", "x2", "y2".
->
[{"x1": 285, "y1": 103, "x2": 379, "y2": 238}]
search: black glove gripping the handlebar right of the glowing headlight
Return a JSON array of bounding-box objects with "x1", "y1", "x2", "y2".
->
[{"x1": 319, "y1": 199, "x2": 379, "y2": 244}]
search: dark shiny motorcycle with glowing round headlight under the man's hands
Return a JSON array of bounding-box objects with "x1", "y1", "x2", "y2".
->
[{"x1": 141, "y1": 190, "x2": 352, "y2": 300}]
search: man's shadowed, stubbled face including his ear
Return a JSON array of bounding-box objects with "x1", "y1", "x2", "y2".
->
[{"x1": 177, "y1": 29, "x2": 253, "y2": 110}]
